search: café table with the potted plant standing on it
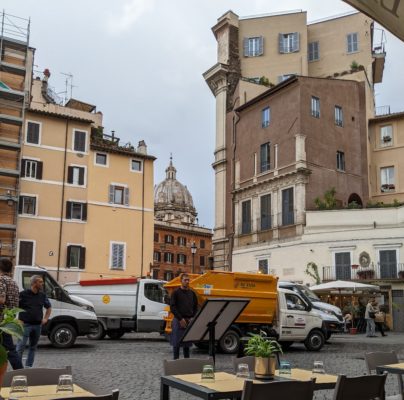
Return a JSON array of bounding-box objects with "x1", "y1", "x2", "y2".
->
[{"x1": 160, "y1": 368, "x2": 337, "y2": 400}]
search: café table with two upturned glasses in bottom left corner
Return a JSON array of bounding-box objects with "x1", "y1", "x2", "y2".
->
[{"x1": 0, "y1": 385, "x2": 95, "y2": 400}]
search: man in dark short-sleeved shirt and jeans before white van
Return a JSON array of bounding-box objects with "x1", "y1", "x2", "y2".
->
[{"x1": 17, "y1": 275, "x2": 52, "y2": 368}]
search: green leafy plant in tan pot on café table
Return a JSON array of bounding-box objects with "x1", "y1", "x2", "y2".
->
[{"x1": 245, "y1": 331, "x2": 282, "y2": 379}]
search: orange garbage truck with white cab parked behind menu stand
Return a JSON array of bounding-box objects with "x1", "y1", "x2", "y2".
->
[{"x1": 164, "y1": 271, "x2": 325, "y2": 353}]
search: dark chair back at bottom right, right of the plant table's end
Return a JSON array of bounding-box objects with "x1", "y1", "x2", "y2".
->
[{"x1": 333, "y1": 373, "x2": 387, "y2": 400}]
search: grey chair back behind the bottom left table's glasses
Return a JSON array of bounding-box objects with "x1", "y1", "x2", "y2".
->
[{"x1": 3, "y1": 366, "x2": 72, "y2": 387}]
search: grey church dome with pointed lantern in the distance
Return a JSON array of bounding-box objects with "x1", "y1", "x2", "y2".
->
[{"x1": 154, "y1": 158, "x2": 198, "y2": 224}]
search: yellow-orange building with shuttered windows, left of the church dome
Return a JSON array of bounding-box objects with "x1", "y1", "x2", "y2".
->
[{"x1": 17, "y1": 75, "x2": 154, "y2": 282}]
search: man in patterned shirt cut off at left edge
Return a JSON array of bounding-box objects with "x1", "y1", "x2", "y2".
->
[{"x1": 0, "y1": 258, "x2": 24, "y2": 369}]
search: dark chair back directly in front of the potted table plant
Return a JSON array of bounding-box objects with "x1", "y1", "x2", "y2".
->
[{"x1": 241, "y1": 379, "x2": 316, "y2": 400}]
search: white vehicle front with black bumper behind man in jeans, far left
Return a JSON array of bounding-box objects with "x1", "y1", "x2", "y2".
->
[{"x1": 14, "y1": 266, "x2": 97, "y2": 348}]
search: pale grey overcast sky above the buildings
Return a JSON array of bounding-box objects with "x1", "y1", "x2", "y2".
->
[{"x1": 1, "y1": 0, "x2": 404, "y2": 228}]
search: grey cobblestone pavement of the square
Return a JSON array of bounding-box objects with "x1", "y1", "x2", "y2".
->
[{"x1": 25, "y1": 333, "x2": 404, "y2": 400}]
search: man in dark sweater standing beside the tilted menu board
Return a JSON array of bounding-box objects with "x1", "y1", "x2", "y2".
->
[{"x1": 170, "y1": 273, "x2": 198, "y2": 360}]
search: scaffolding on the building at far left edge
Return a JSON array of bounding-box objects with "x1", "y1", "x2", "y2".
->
[{"x1": 0, "y1": 11, "x2": 32, "y2": 259}]
